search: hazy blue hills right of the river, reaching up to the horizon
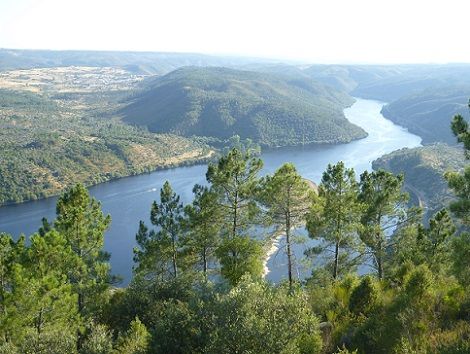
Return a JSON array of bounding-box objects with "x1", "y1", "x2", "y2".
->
[{"x1": 301, "y1": 64, "x2": 470, "y2": 145}]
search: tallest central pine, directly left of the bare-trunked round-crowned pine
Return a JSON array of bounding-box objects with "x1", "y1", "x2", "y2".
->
[{"x1": 206, "y1": 148, "x2": 263, "y2": 284}]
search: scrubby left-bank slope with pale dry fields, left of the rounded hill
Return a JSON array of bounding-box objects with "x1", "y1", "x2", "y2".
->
[{"x1": 0, "y1": 67, "x2": 210, "y2": 205}]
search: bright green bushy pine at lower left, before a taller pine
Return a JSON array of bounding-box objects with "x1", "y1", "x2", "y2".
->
[{"x1": 22, "y1": 230, "x2": 81, "y2": 353}]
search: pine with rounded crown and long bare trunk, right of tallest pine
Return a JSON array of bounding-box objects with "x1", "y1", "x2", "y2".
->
[{"x1": 261, "y1": 163, "x2": 317, "y2": 288}]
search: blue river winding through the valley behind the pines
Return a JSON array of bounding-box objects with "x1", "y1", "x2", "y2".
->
[{"x1": 0, "y1": 99, "x2": 421, "y2": 285}]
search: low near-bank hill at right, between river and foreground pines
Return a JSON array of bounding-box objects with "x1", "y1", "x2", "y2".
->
[{"x1": 372, "y1": 144, "x2": 465, "y2": 217}]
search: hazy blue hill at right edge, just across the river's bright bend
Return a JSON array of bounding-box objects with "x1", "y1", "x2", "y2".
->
[{"x1": 382, "y1": 86, "x2": 470, "y2": 145}]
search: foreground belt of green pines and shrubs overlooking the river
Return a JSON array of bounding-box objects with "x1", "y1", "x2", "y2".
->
[{"x1": 0, "y1": 116, "x2": 470, "y2": 354}]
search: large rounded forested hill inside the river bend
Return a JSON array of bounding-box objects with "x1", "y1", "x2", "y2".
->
[{"x1": 121, "y1": 67, "x2": 366, "y2": 147}]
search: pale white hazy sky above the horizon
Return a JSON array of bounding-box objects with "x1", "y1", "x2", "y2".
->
[{"x1": 0, "y1": 0, "x2": 470, "y2": 63}]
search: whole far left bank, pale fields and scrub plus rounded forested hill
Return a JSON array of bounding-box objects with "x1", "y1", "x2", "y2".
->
[{"x1": 0, "y1": 63, "x2": 366, "y2": 205}]
